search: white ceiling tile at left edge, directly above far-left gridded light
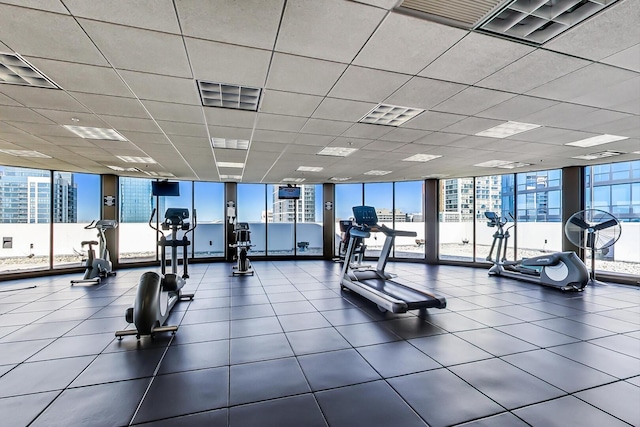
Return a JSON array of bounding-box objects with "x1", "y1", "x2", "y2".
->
[{"x1": 0, "y1": 2, "x2": 107, "y2": 66}]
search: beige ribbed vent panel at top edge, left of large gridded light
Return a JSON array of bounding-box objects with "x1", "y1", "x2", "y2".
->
[{"x1": 400, "y1": 0, "x2": 504, "y2": 28}]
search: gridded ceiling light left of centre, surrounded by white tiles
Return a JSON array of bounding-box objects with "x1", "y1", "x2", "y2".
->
[{"x1": 198, "y1": 80, "x2": 262, "y2": 111}]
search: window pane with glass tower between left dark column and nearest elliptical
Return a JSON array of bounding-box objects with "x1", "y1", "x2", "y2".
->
[{"x1": 118, "y1": 177, "x2": 157, "y2": 263}]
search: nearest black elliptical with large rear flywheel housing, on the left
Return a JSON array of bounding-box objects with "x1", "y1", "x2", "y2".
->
[{"x1": 116, "y1": 208, "x2": 197, "y2": 339}]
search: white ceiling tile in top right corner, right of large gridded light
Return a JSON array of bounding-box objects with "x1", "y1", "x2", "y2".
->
[{"x1": 545, "y1": 0, "x2": 640, "y2": 61}]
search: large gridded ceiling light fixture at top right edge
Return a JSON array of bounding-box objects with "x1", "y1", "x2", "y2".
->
[{"x1": 478, "y1": 0, "x2": 618, "y2": 44}]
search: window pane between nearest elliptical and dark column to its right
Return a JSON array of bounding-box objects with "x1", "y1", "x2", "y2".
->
[{"x1": 193, "y1": 182, "x2": 225, "y2": 258}]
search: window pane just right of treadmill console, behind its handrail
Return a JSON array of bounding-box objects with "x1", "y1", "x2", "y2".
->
[{"x1": 394, "y1": 181, "x2": 425, "y2": 259}]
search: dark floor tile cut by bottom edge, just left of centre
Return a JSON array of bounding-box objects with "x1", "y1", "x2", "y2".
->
[{"x1": 229, "y1": 394, "x2": 327, "y2": 427}]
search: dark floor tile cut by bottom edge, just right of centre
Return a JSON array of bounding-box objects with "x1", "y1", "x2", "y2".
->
[{"x1": 316, "y1": 381, "x2": 427, "y2": 427}]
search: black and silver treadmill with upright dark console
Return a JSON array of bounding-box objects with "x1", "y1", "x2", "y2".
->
[{"x1": 340, "y1": 206, "x2": 447, "y2": 313}]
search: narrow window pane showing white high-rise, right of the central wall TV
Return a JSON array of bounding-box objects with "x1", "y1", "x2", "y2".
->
[{"x1": 296, "y1": 184, "x2": 323, "y2": 256}]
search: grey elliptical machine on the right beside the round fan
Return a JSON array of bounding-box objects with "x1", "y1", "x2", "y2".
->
[{"x1": 484, "y1": 212, "x2": 589, "y2": 291}]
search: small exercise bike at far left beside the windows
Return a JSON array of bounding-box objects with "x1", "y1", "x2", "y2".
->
[{"x1": 71, "y1": 219, "x2": 118, "y2": 285}]
